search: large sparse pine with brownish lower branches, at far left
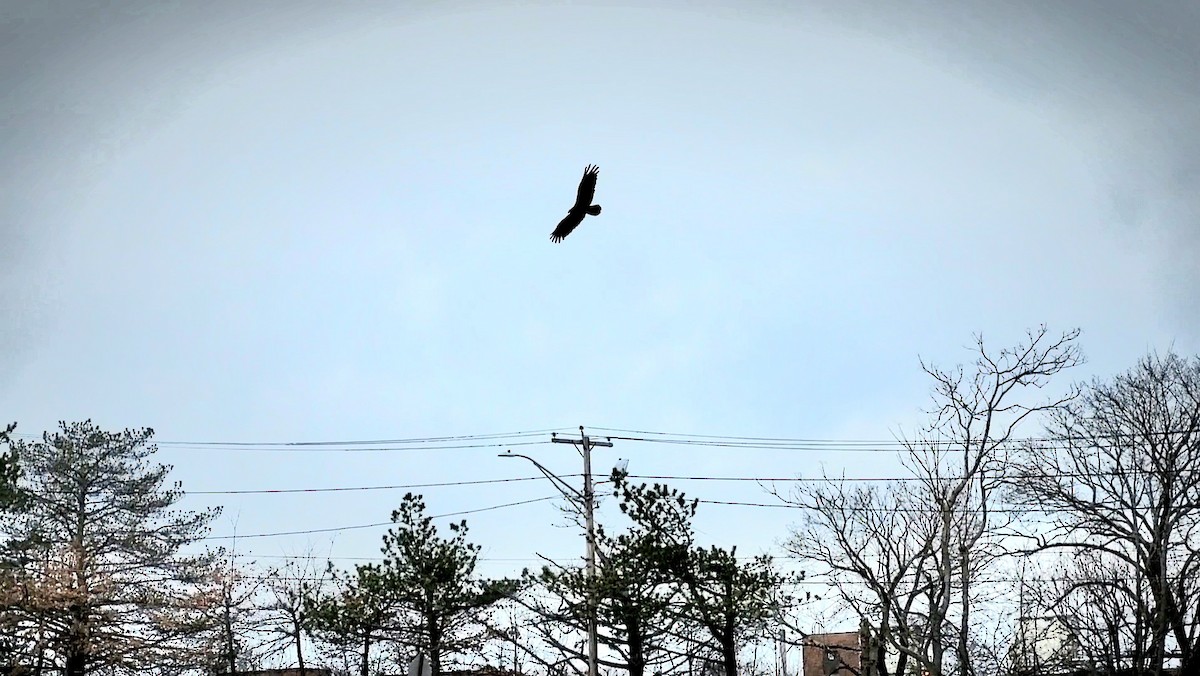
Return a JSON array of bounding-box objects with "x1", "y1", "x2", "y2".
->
[{"x1": 13, "y1": 420, "x2": 220, "y2": 676}]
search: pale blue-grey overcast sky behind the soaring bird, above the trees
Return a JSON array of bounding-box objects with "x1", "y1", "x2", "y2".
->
[{"x1": 0, "y1": 0, "x2": 1200, "y2": 629}]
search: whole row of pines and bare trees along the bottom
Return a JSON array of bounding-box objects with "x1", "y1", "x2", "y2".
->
[{"x1": 0, "y1": 327, "x2": 1200, "y2": 676}]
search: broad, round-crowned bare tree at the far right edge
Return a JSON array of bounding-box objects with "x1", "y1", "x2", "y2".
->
[{"x1": 1013, "y1": 353, "x2": 1200, "y2": 675}]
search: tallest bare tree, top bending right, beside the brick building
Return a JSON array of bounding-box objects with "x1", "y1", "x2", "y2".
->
[{"x1": 781, "y1": 327, "x2": 1081, "y2": 676}]
